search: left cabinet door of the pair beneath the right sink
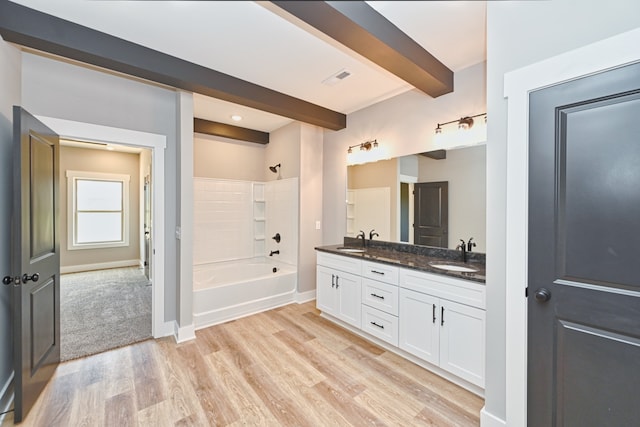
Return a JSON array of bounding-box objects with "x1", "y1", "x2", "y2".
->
[{"x1": 399, "y1": 289, "x2": 440, "y2": 365}]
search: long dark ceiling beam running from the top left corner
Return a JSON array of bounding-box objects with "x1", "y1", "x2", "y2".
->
[{"x1": 0, "y1": 0, "x2": 347, "y2": 130}]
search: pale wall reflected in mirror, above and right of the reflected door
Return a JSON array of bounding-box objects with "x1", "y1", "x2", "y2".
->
[{"x1": 417, "y1": 145, "x2": 487, "y2": 253}]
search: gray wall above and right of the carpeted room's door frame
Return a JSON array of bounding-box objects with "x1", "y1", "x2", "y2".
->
[{"x1": 22, "y1": 53, "x2": 179, "y2": 321}]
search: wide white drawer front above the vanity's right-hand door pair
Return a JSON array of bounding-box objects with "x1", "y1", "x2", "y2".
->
[{"x1": 400, "y1": 268, "x2": 485, "y2": 310}]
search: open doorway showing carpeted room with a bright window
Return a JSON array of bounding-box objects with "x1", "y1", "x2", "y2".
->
[{"x1": 59, "y1": 138, "x2": 152, "y2": 361}]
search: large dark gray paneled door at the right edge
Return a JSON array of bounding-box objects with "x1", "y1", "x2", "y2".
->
[{"x1": 527, "y1": 64, "x2": 640, "y2": 427}]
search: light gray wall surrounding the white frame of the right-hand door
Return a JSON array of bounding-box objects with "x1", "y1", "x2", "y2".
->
[{"x1": 485, "y1": 0, "x2": 640, "y2": 425}]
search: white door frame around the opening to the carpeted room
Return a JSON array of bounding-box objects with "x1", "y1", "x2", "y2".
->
[{"x1": 36, "y1": 116, "x2": 173, "y2": 338}]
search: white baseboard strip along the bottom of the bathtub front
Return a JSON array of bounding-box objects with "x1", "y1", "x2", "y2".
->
[{"x1": 193, "y1": 291, "x2": 296, "y2": 329}]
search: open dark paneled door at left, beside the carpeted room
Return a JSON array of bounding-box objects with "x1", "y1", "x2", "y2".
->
[{"x1": 12, "y1": 107, "x2": 60, "y2": 422}]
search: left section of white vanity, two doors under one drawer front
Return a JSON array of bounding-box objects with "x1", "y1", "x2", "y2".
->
[{"x1": 316, "y1": 252, "x2": 362, "y2": 328}]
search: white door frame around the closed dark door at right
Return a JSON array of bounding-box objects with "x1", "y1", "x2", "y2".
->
[{"x1": 504, "y1": 29, "x2": 640, "y2": 426}]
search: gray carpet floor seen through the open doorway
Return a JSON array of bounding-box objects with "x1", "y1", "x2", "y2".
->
[{"x1": 60, "y1": 267, "x2": 151, "y2": 361}]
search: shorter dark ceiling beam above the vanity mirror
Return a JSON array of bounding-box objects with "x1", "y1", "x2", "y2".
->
[{"x1": 271, "y1": 1, "x2": 453, "y2": 98}]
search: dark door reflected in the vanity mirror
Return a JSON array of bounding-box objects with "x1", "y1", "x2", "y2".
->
[{"x1": 413, "y1": 181, "x2": 449, "y2": 248}]
